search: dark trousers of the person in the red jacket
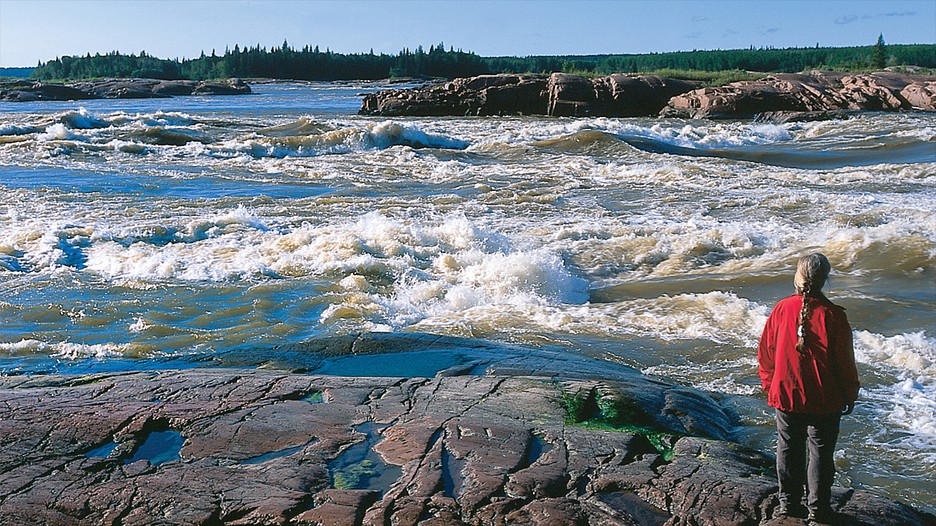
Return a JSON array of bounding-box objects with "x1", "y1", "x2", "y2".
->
[{"x1": 777, "y1": 409, "x2": 842, "y2": 511}]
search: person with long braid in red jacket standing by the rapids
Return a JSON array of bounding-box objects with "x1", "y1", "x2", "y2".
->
[{"x1": 757, "y1": 253, "x2": 860, "y2": 523}]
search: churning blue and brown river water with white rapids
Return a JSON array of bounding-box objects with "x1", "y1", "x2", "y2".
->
[{"x1": 0, "y1": 84, "x2": 936, "y2": 512}]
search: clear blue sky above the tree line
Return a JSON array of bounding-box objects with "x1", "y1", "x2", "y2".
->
[{"x1": 0, "y1": 0, "x2": 936, "y2": 67}]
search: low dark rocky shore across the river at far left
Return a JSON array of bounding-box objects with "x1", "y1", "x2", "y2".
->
[{"x1": 0, "y1": 79, "x2": 251, "y2": 102}]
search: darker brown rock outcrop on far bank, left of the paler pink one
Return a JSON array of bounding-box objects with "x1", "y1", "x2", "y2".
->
[{"x1": 360, "y1": 73, "x2": 699, "y2": 117}]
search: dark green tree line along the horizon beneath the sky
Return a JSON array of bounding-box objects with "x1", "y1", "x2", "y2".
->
[{"x1": 32, "y1": 40, "x2": 936, "y2": 80}]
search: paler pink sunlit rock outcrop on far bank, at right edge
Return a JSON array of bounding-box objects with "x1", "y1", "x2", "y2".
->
[{"x1": 660, "y1": 71, "x2": 936, "y2": 119}]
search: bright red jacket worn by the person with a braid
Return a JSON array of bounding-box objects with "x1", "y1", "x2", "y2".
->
[{"x1": 757, "y1": 296, "x2": 861, "y2": 414}]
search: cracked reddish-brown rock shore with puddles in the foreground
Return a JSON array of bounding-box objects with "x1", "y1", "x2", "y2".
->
[{"x1": 0, "y1": 334, "x2": 936, "y2": 526}]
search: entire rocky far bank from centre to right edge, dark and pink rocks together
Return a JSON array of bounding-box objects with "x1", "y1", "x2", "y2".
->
[{"x1": 360, "y1": 71, "x2": 936, "y2": 121}]
